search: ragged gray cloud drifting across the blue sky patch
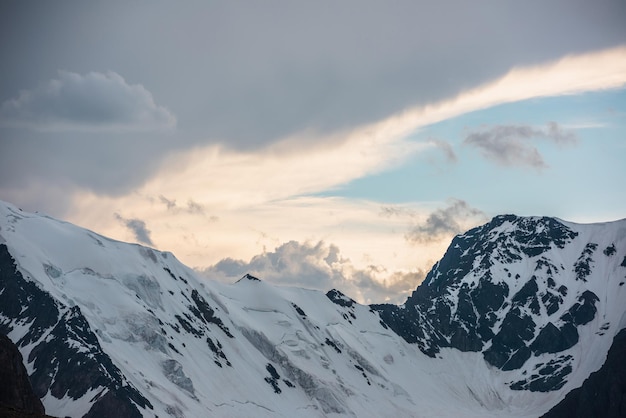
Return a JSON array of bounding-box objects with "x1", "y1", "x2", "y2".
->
[{"x1": 463, "y1": 122, "x2": 576, "y2": 169}]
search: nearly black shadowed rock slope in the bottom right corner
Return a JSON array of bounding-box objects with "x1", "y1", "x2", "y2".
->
[{"x1": 542, "y1": 330, "x2": 626, "y2": 418}]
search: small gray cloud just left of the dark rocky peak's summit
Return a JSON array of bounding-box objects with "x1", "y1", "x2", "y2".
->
[{"x1": 405, "y1": 199, "x2": 486, "y2": 243}]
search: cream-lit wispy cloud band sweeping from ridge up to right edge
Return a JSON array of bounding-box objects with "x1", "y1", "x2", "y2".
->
[{"x1": 62, "y1": 48, "x2": 626, "y2": 298}]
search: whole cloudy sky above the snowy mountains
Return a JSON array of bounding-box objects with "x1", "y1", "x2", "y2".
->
[{"x1": 0, "y1": 0, "x2": 626, "y2": 303}]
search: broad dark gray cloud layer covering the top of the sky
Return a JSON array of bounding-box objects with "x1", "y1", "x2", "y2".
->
[{"x1": 0, "y1": 0, "x2": 626, "y2": 212}]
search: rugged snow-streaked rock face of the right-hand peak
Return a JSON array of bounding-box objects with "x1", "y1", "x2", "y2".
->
[{"x1": 375, "y1": 215, "x2": 623, "y2": 392}]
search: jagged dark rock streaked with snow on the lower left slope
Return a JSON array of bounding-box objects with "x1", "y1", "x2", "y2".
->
[{"x1": 0, "y1": 244, "x2": 152, "y2": 417}]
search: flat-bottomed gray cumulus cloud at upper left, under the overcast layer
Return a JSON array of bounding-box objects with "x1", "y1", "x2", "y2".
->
[{"x1": 0, "y1": 71, "x2": 176, "y2": 132}]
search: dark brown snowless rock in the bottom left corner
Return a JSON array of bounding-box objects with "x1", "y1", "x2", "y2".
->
[{"x1": 0, "y1": 334, "x2": 44, "y2": 416}]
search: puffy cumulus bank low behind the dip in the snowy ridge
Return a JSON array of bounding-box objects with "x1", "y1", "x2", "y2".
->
[{"x1": 202, "y1": 241, "x2": 425, "y2": 303}]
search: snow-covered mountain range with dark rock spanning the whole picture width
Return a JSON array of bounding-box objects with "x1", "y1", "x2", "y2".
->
[{"x1": 0, "y1": 202, "x2": 626, "y2": 417}]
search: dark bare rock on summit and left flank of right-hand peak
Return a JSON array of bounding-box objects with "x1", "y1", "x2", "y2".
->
[{"x1": 373, "y1": 215, "x2": 577, "y2": 360}]
